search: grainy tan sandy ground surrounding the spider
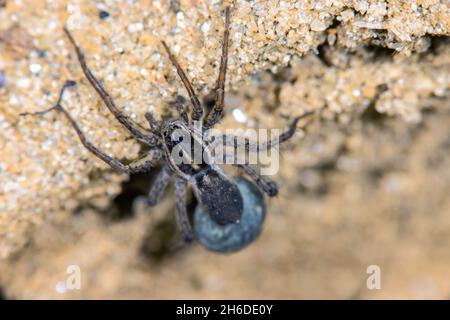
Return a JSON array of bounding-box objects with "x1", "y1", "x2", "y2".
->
[{"x1": 0, "y1": 0, "x2": 450, "y2": 299}]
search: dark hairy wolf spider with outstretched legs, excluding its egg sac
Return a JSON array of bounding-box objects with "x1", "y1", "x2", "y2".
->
[{"x1": 22, "y1": 7, "x2": 311, "y2": 242}]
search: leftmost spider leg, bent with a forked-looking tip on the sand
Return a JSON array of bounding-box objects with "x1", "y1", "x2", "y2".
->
[{"x1": 21, "y1": 81, "x2": 161, "y2": 174}]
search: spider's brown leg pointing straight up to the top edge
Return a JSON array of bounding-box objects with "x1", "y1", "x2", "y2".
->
[{"x1": 204, "y1": 7, "x2": 230, "y2": 129}]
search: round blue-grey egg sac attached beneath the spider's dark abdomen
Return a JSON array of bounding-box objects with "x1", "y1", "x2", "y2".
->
[{"x1": 194, "y1": 177, "x2": 266, "y2": 253}]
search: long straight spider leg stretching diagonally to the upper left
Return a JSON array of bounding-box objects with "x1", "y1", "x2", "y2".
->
[{"x1": 64, "y1": 28, "x2": 158, "y2": 146}]
